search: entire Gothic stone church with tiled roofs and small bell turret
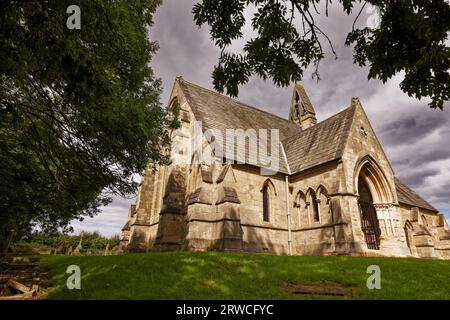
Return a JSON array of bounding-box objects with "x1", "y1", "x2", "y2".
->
[{"x1": 121, "y1": 77, "x2": 450, "y2": 259}]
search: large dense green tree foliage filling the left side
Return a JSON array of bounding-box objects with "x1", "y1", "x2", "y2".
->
[{"x1": 0, "y1": 0, "x2": 171, "y2": 240}]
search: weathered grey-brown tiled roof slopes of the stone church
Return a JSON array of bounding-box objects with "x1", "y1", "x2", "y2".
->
[{"x1": 178, "y1": 77, "x2": 438, "y2": 212}]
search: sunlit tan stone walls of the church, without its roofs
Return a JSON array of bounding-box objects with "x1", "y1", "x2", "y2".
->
[{"x1": 117, "y1": 86, "x2": 450, "y2": 258}]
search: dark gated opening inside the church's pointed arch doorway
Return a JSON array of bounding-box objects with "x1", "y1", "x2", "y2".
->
[{"x1": 358, "y1": 176, "x2": 381, "y2": 250}]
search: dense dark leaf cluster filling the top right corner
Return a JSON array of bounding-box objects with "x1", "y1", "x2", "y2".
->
[{"x1": 346, "y1": 0, "x2": 450, "y2": 109}]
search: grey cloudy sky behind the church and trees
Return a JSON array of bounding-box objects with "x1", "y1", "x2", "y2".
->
[{"x1": 73, "y1": 0, "x2": 450, "y2": 236}]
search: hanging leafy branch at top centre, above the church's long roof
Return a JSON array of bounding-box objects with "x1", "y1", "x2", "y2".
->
[{"x1": 193, "y1": 0, "x2": 323, "y2": 96}]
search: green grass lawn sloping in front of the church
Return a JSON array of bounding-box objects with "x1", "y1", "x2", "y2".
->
[{"x1": 41, "y1": 252, "x2": 450, "y2": 299}]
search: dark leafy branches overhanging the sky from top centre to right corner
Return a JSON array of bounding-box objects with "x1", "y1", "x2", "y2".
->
[{"x1": 193, "y1": 0, "x2": 450, "y2": 109}]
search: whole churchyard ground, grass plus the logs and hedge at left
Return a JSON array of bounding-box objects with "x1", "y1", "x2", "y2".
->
[{"x1": 0, "y1": 233, "x2": 450, "y2": 300}]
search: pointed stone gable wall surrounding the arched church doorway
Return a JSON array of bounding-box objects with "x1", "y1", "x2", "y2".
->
[{"x1": 342, "y1": 98, "x2": 409, "y2": 256}]
